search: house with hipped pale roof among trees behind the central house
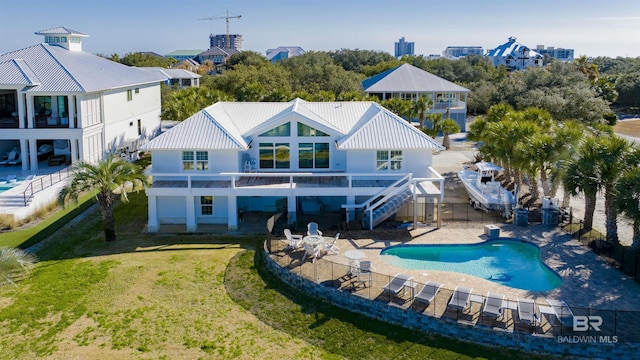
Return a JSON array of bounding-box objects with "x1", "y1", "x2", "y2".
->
[{"x1": 362, "y1": 64, "x2": 470, "y2": 131}]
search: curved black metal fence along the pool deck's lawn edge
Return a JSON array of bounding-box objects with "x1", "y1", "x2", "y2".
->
[{"x1": 265, "y1": 238, "x2": 640, "y2": 343}]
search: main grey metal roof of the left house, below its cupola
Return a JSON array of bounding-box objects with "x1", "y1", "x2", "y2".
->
[{"x1": 0, "y1": 44, "x2": 165, "y2": 92}]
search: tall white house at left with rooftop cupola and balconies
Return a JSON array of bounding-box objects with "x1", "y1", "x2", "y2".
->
[{"x1": 0, "y1": 27, "x2": 164, "y2": 171}]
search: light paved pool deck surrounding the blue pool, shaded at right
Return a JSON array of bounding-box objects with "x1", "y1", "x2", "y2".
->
[{"x1": 272, "y1": 223, "x2": 640, "y2": 311}]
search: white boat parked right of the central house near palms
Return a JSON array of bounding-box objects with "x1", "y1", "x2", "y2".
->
[{"x1": 458, "y1": 161, "x2": 516, "y2": 219}]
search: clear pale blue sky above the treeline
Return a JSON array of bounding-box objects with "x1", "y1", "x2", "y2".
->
[{"x1": 0, "y1": 0, "x2": 640, "y2": 57}]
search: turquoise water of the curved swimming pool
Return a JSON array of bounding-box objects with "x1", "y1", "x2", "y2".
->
[{"x1": 380, "y1": 238, "x2": 562, "y2": 291}]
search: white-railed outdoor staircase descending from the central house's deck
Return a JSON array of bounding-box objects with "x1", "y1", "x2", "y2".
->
[{"x1": 362, "y1": 174, "x2": 413, "y2": 230}]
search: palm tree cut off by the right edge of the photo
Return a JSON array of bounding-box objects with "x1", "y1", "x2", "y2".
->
[{"x1": 616, "y1": 167, "x2": 640, "y2": 249}]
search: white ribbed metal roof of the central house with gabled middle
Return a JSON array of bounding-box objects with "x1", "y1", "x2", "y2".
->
[{"x1": 142, "y1": 99, "x2": 442, "y2": 150}]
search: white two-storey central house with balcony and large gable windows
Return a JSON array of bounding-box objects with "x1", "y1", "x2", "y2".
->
[{"x1": 142, "y1": 99, "x2": 443, "y2": 232}]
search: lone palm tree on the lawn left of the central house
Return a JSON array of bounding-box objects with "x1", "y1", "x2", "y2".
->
[{"x1": 59, "y1": 154, "x2": 147, "y2": 241}]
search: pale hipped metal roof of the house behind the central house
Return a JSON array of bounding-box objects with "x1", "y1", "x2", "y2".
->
[{"x1": 362, "y1": 64, "x2": 470, "y2": 93}]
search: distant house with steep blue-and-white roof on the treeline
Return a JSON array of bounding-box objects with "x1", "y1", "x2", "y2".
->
[{"x1": 484, "y1": 36, "x2": 544, "y2": 71}]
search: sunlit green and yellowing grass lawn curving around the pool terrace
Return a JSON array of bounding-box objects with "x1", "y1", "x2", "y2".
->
[{"x1": 0, "y1": 194, "x2": 552, "y2": 359}]
